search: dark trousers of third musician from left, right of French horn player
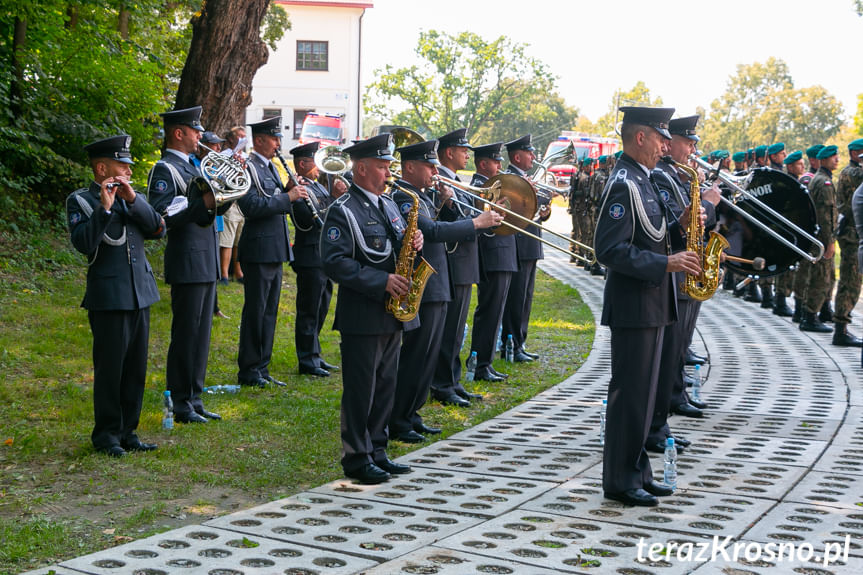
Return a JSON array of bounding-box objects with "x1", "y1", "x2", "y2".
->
[{"x1": 237, "y1": 262, "x2": 282, "y2": 381}]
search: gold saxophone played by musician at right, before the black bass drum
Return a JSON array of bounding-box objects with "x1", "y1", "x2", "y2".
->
[{"x1": 674, "y1": 162, "x2": 729, "y2": 301}]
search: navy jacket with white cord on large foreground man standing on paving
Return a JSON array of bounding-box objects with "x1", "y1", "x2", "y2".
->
[{"x1": 594, "y1": 153, "x2": 683, "y2": 328}]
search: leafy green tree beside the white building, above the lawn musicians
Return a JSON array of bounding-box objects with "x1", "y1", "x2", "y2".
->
[{"x1": 365, "y1": 30, "x2": 577, "y2": 148}]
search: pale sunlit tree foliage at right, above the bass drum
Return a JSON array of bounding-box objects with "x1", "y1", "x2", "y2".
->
[{"x1": 701, "y1": 58, "x2": 843, "y2": 151}]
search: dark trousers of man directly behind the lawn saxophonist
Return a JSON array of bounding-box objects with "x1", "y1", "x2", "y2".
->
[{"x1": 390, "y1": 301, "x2": 447, "y2": 435}]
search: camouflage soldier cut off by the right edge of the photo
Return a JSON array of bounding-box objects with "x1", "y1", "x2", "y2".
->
[{"x1": 833, "y1": 138, "x2": 863, "y2": 347}]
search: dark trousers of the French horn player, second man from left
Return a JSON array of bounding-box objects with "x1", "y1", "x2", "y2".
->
[{"x1": 166, "y1": 281, "x2": 216, "y2": 416}]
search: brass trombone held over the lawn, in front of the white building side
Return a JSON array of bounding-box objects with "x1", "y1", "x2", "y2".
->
[{"x1": 434, "y1": 174, "x2": 596, "y2": 265}]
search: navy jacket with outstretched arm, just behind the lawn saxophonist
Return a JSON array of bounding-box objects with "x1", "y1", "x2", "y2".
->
[{"x1": 393, "y1": 180, "x2": 476, "y2": 302}]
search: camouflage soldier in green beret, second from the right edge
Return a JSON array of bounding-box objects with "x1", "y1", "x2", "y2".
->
[{"x1": 800, "y1": 146, "x2": 839, "y2": 333}]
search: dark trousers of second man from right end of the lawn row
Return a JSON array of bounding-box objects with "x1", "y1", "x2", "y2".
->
[{"x1": 470, "y1": 272, "x2": 512, "y2": 370}]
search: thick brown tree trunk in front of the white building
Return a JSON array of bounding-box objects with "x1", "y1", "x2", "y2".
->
[{"x1": 175, "y1": 0, "x2": 270, "y2": 133}]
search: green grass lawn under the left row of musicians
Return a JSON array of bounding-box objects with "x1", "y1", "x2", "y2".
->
[{"x1": 0, "y1": 216, "x2": 594, "y2": 573}]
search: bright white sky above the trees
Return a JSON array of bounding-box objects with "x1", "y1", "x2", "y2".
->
[{"x1": 362, "y1": 0, "x2": 863, "y2": 125}]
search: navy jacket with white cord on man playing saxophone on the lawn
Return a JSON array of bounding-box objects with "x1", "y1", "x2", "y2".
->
[{"x1": 321, "y1": 184, "x2": 419, "y2": 335}]
